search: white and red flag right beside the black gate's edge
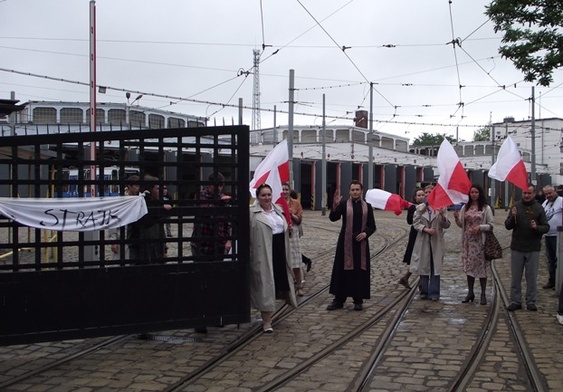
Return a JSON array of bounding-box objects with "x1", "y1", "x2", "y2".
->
[{"x1": 249, "y1": 139, "x2": 291, "y2": 225}]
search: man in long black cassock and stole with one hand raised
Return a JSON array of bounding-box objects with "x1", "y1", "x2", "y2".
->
[{"x1": 327, "y1": 180, "x2": 376, "y2": 310}]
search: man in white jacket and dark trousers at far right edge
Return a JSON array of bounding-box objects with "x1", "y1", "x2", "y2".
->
[{"x1": 542, "y1": 185, "x2": 563, "y2": 289}]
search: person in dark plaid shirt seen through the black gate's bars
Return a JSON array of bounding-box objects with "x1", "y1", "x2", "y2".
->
[{"x1": 191, "y1": 172, "x2": 232, "y2": 262}]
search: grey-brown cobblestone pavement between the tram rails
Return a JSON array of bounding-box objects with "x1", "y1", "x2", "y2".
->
[{"x1": 0, "y1": 210, "x2": 563, "y2": 392}]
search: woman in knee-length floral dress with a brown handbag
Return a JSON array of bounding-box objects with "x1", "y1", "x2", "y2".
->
[{"x1": 454, "y1": 184, "x2": 493, "y2": 305}]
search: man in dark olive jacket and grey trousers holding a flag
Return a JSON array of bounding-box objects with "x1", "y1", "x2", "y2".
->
[{"x1": 504, "y1": 184, "x2": 549, "y2": 311}]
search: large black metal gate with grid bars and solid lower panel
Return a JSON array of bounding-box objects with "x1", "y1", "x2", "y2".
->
[{"x1": 0, "y1": 126, "x2": 250, "y2": 345}]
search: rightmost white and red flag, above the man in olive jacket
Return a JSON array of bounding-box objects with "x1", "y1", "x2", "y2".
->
[{"x1": 489, "y1": 136, "x2": 528, "y2": 190}]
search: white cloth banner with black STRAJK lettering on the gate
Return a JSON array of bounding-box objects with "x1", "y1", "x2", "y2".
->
[{"x1": 0, "y1": 195, "x2": 148, "y2": 231}]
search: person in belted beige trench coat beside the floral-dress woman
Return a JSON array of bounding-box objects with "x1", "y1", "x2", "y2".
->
[{"x1": 411, "y1": 203, "x2": 451, "y2": 301}]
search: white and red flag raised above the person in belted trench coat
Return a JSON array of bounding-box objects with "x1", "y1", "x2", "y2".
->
[{"x1": 426, "y1": 139, "x2": 471, "y2": 210}]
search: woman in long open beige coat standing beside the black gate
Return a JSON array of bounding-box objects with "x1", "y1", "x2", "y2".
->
[{"x1": 250, "y1": 184, "x2": 297, "y2": 333}]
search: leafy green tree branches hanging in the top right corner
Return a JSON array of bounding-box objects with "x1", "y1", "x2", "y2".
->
[{"x1": 485, "y1": 0, "x2": 563, "y2": 86}]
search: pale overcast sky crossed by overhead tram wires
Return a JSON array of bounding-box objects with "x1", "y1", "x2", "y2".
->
[{"x1": 0, "y1": 0, "x2": 563, "y2": 140}]
